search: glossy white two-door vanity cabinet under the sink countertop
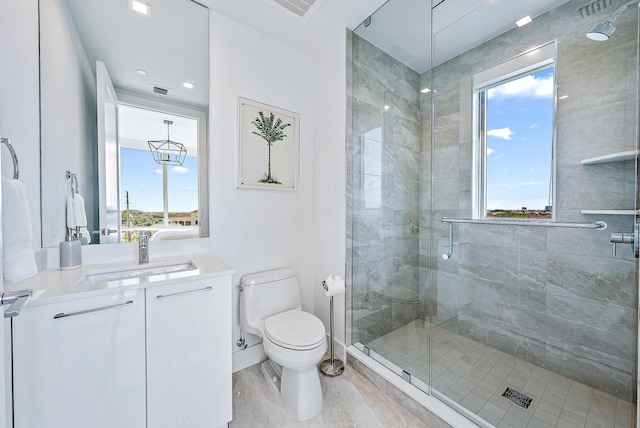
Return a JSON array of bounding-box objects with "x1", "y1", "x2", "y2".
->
[{"x1": 12, "y1": 274, "x2": 232, "y2": 428}]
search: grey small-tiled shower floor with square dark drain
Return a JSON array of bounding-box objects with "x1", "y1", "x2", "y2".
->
[{"x1": 368, "y1": 320, "x2": 635, "y2": 428}]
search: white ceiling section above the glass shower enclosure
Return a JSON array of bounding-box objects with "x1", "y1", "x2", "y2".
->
[{"x1": 355, "y1": 0, "x2": 568, "y2": 73}]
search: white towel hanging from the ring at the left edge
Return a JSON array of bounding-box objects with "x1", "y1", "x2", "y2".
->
[{"x1": 2, "y1": 177, "x2": 38, "y2": 282}]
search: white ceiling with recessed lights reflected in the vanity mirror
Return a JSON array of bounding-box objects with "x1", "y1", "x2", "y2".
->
[{"x1": 64, "y1": 0, "x2": 209, "y2": 108}]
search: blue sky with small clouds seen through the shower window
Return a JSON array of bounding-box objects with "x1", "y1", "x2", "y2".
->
[{"x1": 487, "y1": 68, "x2": 553, "y2": 210}]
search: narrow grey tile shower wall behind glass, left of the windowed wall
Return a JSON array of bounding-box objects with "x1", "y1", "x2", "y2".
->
[{"x1": 347, "y1": 34, "x2": 424, "y2": 343}]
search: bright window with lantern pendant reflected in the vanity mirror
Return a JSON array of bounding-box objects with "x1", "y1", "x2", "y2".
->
[{"x1": 118, "y1": 105, "x2": 200, "y2": 242}]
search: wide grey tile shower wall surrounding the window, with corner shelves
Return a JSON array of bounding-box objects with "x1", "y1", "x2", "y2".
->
[{"x1": 420, "y1": 0, "x2": 638, "y2": 400}]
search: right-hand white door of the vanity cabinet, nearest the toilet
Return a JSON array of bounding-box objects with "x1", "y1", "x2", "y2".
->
[{"x1": 147, "y1": 277, "x2": 232, "y2": 428}]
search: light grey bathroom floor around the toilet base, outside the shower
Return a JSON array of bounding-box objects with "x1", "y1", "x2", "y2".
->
[{"x1": 229, "y1": 364, "x2": 427, "y2": 428}]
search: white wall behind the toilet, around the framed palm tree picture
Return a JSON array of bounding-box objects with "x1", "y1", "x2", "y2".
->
[{"x1": 209, "y1": 11, "x2": 315, "y2": 358}]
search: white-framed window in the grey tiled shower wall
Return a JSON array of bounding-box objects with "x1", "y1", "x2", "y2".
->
[{"x1": 474, "y1": 43, "x2": 555, "y2": 219}]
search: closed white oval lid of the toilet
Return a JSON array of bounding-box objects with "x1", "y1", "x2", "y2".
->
[{"x1": 264, "y1": 309, "x2": 325, "y2": 350}]
